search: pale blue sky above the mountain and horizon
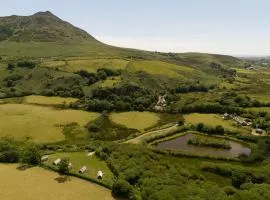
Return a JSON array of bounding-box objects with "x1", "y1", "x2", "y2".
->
[{"x1": 0, "y1": 0, "x2": 270, "y2": 55}]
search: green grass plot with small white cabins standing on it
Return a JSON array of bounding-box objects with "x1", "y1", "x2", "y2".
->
[{"x1": 45, "y1": 152, "x2": 113, "y2": 187}]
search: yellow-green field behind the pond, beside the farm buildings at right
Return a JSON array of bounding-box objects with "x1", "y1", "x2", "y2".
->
[{"x1": 184, "y1": 113, "x2": 247, "y2": 131}]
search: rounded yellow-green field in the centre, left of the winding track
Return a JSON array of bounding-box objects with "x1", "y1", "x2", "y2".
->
[{"x1": 110, "y1": 112, "x2": 160, "y2": 131}]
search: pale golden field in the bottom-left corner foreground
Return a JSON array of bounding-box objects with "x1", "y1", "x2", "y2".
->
[{"x1": 0, "y1": 164, "x2": 114, "y2": 200}]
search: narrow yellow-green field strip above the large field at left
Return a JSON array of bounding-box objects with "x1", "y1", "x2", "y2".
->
[{"x1": 24, "y1": 95, "x2": 79, "y2": 105}]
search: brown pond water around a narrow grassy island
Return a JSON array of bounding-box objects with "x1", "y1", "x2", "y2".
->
[{"x1": 156, "y1": 133, "x2": 251, "y2": 157}]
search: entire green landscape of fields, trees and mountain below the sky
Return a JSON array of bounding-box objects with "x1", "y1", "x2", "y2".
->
[{"x1": 0, "y1": 12, "x2": 270, "y2": 200}]
